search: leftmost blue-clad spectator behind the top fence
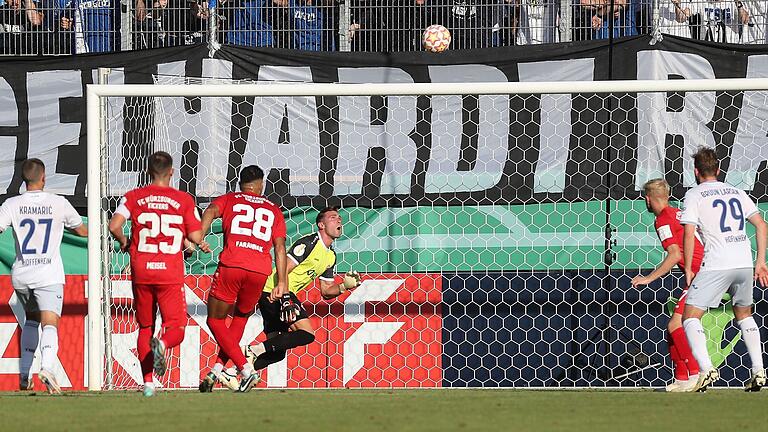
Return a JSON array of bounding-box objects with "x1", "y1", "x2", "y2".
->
[{"x1": 61, "y1": 0, "x2": 120, "y2": 54}]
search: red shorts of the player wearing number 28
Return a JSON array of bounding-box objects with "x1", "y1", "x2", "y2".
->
[{"x1": 210, "y1": 266, "x2": 269, "y2": 313}]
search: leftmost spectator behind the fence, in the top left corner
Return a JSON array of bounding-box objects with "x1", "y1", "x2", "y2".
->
[{"x1": 0, "y1": 0, "x2": 43, "y2": 55}]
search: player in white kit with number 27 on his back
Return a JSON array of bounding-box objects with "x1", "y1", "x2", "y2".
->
[{"x1": 0, "y1": 159, "x2": 88, "y2": 394}]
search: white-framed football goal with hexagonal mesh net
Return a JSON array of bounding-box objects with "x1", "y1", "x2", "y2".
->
[{"x1": 88, "y1": 80, "x2": 768, "y2": 389}]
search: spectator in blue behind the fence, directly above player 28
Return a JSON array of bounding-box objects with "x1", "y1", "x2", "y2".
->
[{"x1": 222, "y1": 0, "x2": 288, "y2": 47}]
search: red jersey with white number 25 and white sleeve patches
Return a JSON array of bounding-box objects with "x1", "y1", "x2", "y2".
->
[{"x1": 116, "y1": 185, "x2": 202, "y2": 285}]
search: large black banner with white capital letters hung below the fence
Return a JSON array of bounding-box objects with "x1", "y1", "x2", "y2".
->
[{"x1": 0, "y1": 37, "x2": 768, "y2": 206}]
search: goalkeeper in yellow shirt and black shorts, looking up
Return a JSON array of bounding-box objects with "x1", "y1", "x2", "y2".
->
[{"x1": 249, "y1": 207, "x2": 360, "y2": 370}]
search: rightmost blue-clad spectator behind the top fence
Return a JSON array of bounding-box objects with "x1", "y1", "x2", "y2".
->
[{"x1": 581, "y1": 0, "x2": 637, "y2": 39}]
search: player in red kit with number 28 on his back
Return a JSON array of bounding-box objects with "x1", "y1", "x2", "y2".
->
[{"x1": 199, "y1": 165, "x2": 288, "y2": 392}]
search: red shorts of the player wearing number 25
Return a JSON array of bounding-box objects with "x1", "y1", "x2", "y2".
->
[{"x1": 133, "y1": 284, "x2": 187, "y2": 327}]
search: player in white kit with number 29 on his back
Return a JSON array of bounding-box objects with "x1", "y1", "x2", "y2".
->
[{"x1": 680, "y1": 148, "x2": 768, "y2": 391}]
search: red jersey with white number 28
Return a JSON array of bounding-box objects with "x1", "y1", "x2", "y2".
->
[{"x1": 211, "y1": 192, "x2": 285, "y2": 275}]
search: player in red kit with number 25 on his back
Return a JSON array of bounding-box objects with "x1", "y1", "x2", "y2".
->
[{"x1": 109, "y1": 151, "x2": 210, "y2": 396}]
